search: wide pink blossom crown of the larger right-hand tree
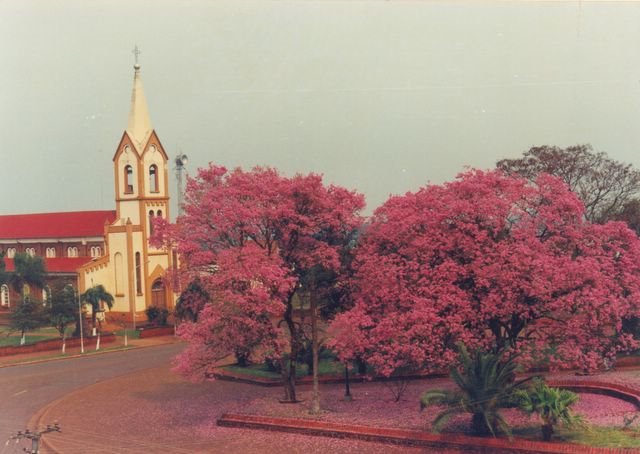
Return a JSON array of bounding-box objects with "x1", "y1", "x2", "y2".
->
[{"x1": 331, "y1": 171, "x2": 640, "y2": 376}]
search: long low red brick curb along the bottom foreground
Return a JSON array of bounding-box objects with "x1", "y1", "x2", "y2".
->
[{"x1": 217, "y1": 413, "x2": 638, "y2": 454}]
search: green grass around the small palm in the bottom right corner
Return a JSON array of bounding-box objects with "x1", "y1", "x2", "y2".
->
[{"x1": 513, "y1": 426, "x2": 640, "y2": 448}]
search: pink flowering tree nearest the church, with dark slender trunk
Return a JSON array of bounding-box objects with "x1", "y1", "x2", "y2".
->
[{"x1": 154, "y1": 165, "x2": 364, "y2": 401}]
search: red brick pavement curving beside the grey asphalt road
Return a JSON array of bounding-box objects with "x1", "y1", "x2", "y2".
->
[{"x1": 30, "y1": 367, "x2": 432, "y2": 454}]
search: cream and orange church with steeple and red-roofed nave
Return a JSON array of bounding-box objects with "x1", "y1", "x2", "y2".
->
[{"x1": 0, "y1": 63, "x2": 177, "y2": 321}]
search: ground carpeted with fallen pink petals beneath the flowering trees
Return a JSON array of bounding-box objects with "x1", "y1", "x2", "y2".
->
[{"x1": 218, "y1": 378, "x2": 640, "y2": 443}]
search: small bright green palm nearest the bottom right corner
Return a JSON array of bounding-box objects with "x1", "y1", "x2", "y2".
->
[{"x1": 515, "y1": 380, "x2": 584, "y2": 441}]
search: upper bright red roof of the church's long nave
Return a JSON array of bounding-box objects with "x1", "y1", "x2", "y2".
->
[{"x1": 0, "y1": 210, "x2": 116, "y2": 240}]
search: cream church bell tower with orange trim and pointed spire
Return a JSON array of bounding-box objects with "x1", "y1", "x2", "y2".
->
[{"x1": 96, "y1": 52, "x2": 176, "y2": 323}]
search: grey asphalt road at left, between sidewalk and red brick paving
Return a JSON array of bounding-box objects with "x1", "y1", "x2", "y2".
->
[{"x1": 0, "y1": 344, "x2": 183, "y2": 446}]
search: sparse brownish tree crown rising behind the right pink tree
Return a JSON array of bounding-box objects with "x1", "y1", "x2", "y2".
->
[{"x1": 497, "y1": 144, "x2": 640, "y2": 223}]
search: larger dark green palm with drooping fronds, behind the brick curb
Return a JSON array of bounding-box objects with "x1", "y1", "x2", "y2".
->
[{"x1": 420, "y1": 346, "x2": 529, "y2": 436}]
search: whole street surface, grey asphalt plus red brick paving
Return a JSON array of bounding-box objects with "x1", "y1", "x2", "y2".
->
[{"x1": 0, "y1": 344, "x2": 440, "y2": 454}]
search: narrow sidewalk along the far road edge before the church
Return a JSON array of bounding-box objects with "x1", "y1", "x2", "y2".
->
[{"x1": 0, "y1": 336, "x2": 180, "y2": 368}]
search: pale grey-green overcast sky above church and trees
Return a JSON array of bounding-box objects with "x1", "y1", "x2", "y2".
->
[{"x1": 0, "y1": 0, "x2": 640, "y2": 218}]
